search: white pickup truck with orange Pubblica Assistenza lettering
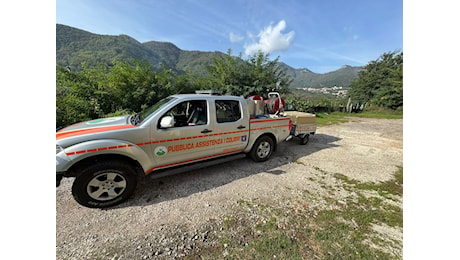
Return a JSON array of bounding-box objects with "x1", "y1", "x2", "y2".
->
[{"x1": 56, "y1": 94, "x2": 292, "y2": 208}]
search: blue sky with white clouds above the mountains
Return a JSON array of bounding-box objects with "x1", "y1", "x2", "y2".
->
[{"x1": 56, "y1": 0, "x2": 403, "y2": 73}]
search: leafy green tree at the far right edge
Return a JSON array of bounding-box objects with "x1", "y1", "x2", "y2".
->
[{"x1": 348, "y1": 51, "x2": 403, "y2": 109}]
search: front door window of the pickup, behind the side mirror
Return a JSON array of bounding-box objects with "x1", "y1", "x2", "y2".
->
[{"x1": 160, "y1": 100, "x2": 208, "y2": 127}]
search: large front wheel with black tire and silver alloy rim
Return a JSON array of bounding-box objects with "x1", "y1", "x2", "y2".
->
[{"x1": 72, "y1": 161, "x2": 137, "y2": 208}]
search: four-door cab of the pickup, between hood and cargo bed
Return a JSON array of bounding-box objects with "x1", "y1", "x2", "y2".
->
[{"x1": 145, "y1": 95, "x2": 249, "y2": 171}]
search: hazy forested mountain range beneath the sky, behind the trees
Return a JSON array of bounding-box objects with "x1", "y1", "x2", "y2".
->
[{"x1": 56, "y1": 24, "x2": 363, "y2": 89}]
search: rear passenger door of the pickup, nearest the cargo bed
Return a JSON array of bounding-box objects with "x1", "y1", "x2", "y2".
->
[{"x1": 215, "y1": 99, "x2": 249, "y2": 155}]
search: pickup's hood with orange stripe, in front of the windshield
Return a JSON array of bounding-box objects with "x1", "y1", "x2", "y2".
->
[{"x1": 56, "y1": 115, "x2": 134, "y2": 140}]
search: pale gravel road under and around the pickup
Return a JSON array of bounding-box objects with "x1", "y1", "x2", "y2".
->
[{"x1": 56, "y1": 117, "x2": 403, "y2": 259}]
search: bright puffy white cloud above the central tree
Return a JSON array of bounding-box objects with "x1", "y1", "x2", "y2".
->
[{"x1": 244, "y1": 20, "x2": 295, "y2": 55}]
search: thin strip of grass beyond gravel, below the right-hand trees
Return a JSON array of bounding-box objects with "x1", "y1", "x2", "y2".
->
[{"x1": 316, "y1": 111, "x2": 403, "y2": 126}]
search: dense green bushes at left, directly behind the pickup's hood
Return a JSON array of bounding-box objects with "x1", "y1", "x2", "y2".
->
[{"x1": 56, "y1": 61, "x2": 187, "y2": 127}]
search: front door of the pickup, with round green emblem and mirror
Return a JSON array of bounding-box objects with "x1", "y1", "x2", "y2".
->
[{"x1": 152, "y1": 99, "x2": 214, "y2": 170}]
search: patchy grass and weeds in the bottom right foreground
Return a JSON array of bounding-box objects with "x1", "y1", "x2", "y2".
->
[{"x1": 192, "y1": 167, "x2": 403, "y2": 259}]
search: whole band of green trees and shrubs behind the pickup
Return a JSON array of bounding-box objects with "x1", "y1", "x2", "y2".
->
[{"x1": 56, "y1": 50, "x2": 403, "y2": 128}]
